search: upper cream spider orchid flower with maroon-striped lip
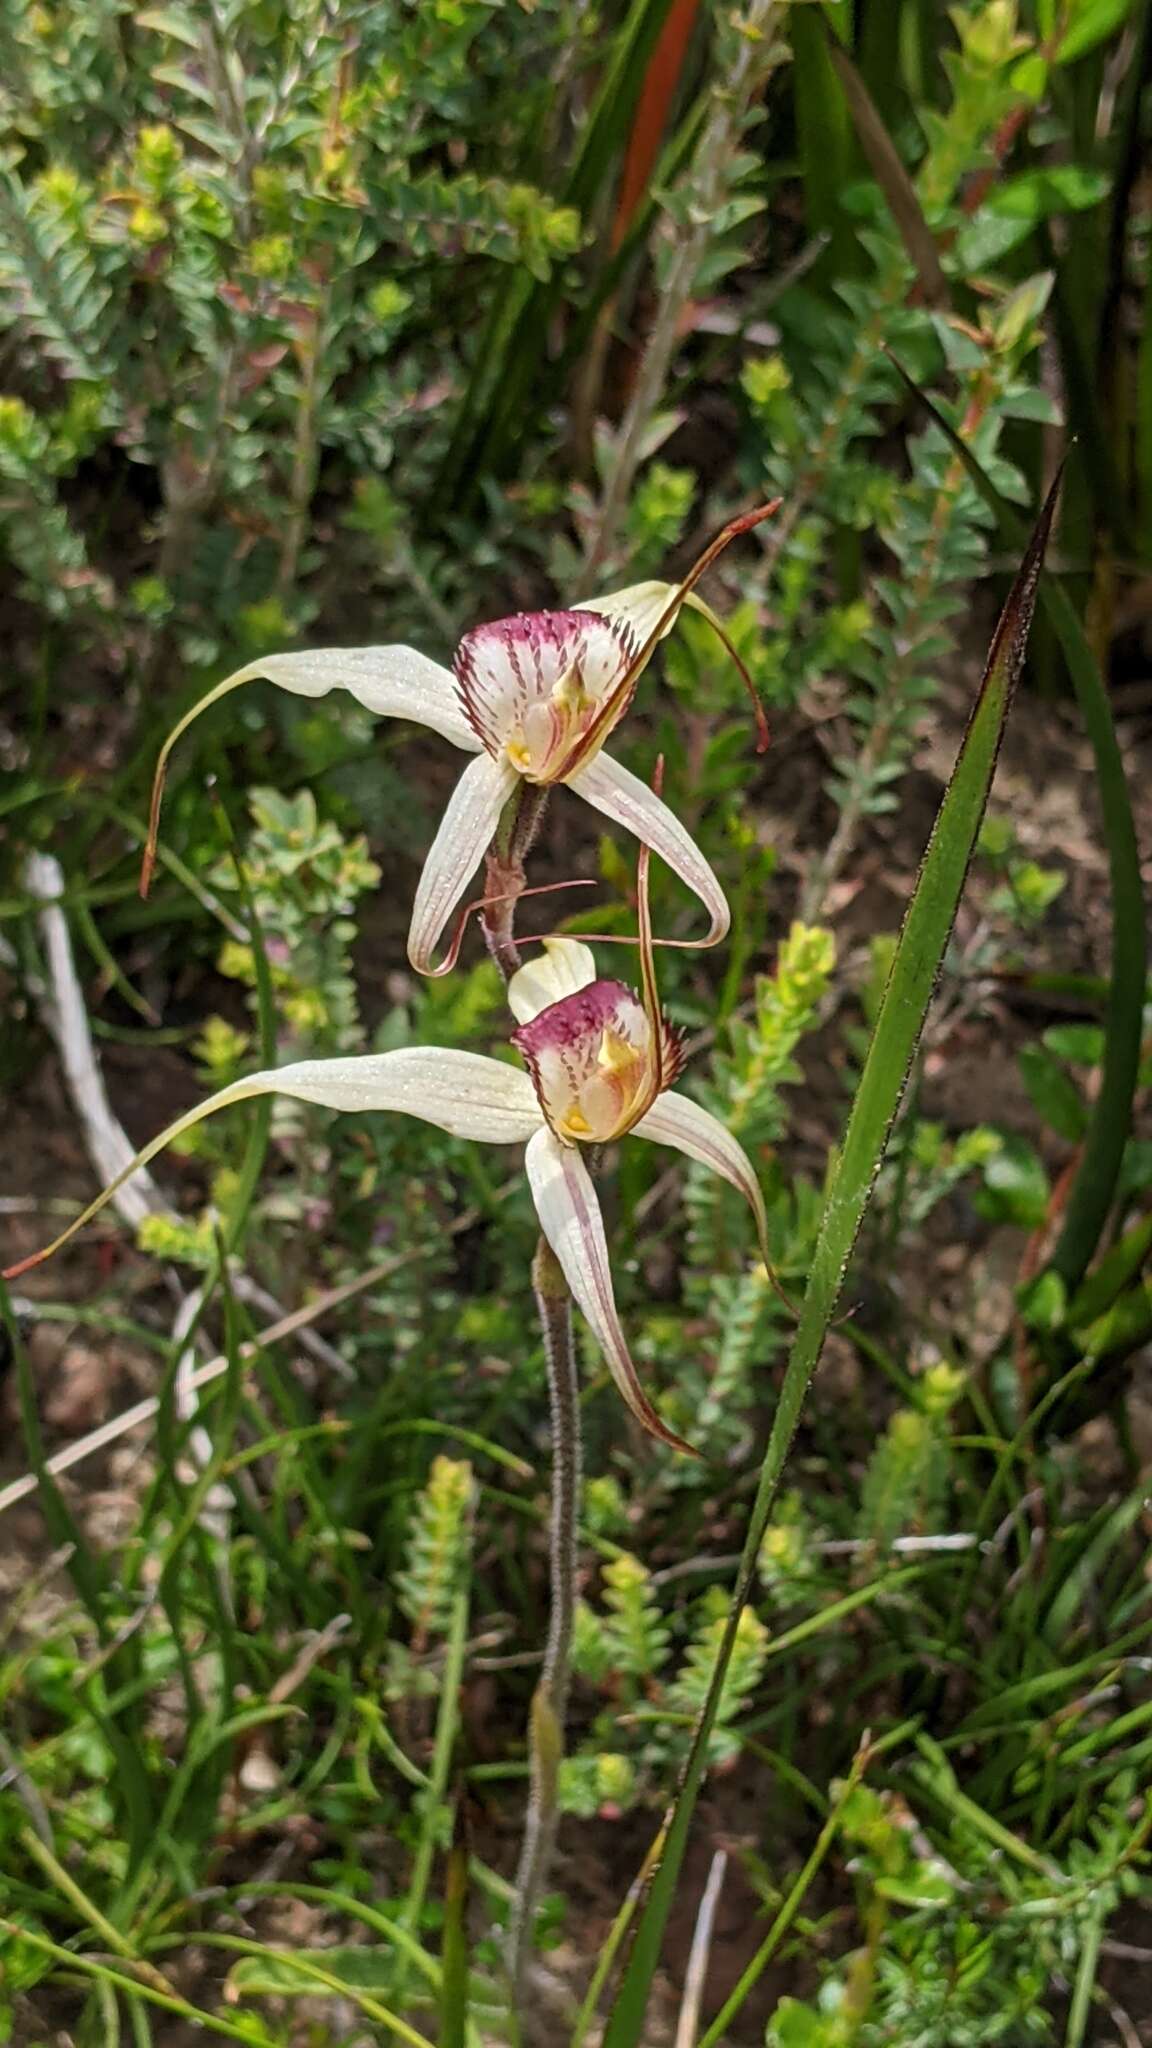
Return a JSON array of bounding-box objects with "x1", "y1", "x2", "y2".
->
[{"x1": 141, "y1": 500, "x2": 779, "y2": 973}]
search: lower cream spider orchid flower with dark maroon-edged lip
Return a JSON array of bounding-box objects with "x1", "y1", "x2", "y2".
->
[{"x1": 4, "y1": 958, "x2": 767, "y2": 1450}]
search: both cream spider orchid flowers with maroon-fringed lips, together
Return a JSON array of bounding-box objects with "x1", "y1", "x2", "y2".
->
[{"x1": 6, "y1": 504, "x2": 775, "y2": 1450}]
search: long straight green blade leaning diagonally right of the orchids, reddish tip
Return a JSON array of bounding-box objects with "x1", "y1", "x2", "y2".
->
[{"x1": 603, "y1": 468, "x2": 1058, "y2": 2048}]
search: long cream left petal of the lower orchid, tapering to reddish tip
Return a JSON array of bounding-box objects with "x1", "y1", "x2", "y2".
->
[{"x1": 4, "y1": 1047, "x2": 539, "y2": 1280}]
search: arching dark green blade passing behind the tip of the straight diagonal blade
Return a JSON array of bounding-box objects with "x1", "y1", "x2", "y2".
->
[{"x1": 877, "y1": 356, "x2": 1148, "y2": 1290}]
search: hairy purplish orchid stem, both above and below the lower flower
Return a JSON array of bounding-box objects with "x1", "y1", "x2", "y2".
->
[{"x1": 482, "y1": 784, "x2": 582, "y2": 2013}]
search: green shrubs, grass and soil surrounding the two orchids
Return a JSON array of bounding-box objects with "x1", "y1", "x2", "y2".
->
[{"x1": 0, "y1": 0, "x2": 1152, "y2": 2048}]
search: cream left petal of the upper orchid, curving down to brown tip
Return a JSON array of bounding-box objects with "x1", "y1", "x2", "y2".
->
[{"x1": 139, "y1": 645, "x2": 480, "y2": 895}]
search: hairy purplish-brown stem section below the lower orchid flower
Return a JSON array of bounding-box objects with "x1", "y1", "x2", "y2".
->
[{"x1": 508, "y1": 1237, "x2": 582, "y2": 2007}]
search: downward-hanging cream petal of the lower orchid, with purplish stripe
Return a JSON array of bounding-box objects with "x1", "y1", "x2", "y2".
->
[{"x1": 525, "y1": 1130, "x2": 691, "y2": 1450}]
